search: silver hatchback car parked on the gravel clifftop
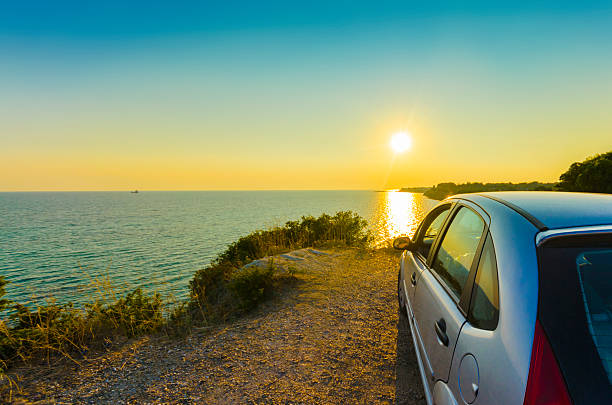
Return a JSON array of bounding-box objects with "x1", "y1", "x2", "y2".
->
[{"x1": 394, "y1": 192, "x2": 612, "y2": 405}]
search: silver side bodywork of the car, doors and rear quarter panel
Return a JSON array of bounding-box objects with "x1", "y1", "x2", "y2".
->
[{"x1": 401, "y1": 195, "x2": 538, "y2": 404}]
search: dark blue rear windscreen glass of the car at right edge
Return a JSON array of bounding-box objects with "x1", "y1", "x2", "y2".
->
[{"x1": 576, "y1": 250, "x2": 612, "y2": 383}]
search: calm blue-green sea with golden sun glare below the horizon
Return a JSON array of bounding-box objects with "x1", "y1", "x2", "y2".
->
[{"x1": 0, "y1": 191, "x2": 436, "y2": 303}]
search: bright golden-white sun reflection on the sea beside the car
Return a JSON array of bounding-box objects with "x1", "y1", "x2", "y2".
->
[{"x1": 371, "y1": 191, "x2": 438, "y2": 247}]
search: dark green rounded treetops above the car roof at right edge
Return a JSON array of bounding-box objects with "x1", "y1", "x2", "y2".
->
[{"x1": 559, "y1": 151, "x2": 612, "y2": 193}]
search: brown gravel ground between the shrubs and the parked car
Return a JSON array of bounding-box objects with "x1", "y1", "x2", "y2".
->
[{"x1": 13, "y1": 250, "x2": 424, "y2": 404}]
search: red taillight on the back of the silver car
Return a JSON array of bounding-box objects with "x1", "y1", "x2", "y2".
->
[{"x1": 523, "y1": 321, "x2": 572, "y2": 405}]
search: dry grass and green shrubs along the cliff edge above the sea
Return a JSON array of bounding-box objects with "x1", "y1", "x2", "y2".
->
[{"x1": 0, "y1": 211, "x2": 370, "y2": 391}]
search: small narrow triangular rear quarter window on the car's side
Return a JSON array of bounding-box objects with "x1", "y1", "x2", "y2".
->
[{"x1": 469, "y1": 235, "x2": 499, "y2": 330}]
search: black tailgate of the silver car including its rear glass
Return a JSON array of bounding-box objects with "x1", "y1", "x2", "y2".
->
[{"x1": 538, "y1": 234, "x2": 612, "y2": 404}]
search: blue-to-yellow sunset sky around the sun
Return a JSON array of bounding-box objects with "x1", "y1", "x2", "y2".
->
[{"x1": 0, "y1": 0, "x2": 612, "y2": 191}]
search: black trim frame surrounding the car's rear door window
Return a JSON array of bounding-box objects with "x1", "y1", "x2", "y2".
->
[{"x1": 427, "y1": 202, "x2": 489, "y2": 319}]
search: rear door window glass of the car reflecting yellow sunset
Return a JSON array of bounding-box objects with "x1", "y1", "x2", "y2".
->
[{"x1": 433, "y1": 207, "x2": 485, "y2": 299}]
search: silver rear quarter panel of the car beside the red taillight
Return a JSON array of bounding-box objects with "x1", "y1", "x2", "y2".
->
[{"x1": 449, "y1": 195, "x2": 538, "y2": 404}]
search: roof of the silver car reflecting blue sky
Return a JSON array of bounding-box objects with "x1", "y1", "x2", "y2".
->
[{"x1": 451, "y1": 191, "x2": 612, "y2": 231}]
